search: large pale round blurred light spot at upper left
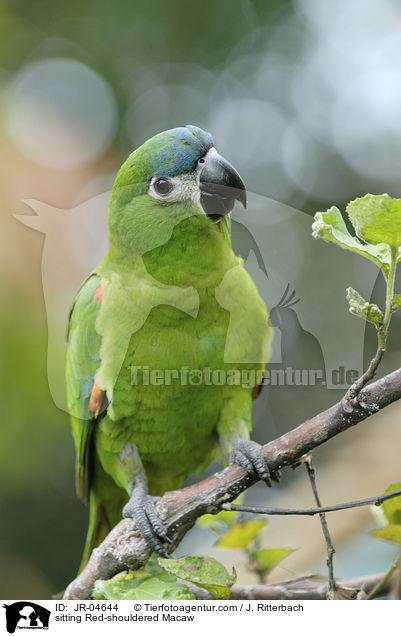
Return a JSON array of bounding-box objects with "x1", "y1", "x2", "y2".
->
[{"x1": 5, "y1": 58, "x2": 118, "y2": 170}]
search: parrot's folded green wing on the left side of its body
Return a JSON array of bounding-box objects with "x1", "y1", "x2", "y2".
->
[{"x1": 66, "y1": 274, "x2": 101, "y2": 501}]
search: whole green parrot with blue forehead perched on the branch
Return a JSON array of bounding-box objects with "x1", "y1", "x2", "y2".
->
[{"x1": 66, "y1": 126, "x2": 275, "y2": 569}]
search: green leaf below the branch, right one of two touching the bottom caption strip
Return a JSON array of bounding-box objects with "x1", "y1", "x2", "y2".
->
[{"x1": 159, "y1": 555, "x2": 236, "y2": 599}]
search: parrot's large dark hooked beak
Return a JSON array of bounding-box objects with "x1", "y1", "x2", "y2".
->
[{"x1": 199, "y1": 148, "x2": 247, "y2": 221}]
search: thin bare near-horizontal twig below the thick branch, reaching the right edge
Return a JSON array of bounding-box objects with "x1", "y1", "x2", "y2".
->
[{"x1": 221, "y1": 490, "x2": 401, "y2": 516}]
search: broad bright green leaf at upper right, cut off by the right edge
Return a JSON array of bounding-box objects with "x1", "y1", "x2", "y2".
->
[{"x1": 347, "y1": 194, "x2": 401, "y2": 249}]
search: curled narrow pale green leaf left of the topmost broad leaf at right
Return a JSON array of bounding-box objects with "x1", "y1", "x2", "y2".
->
[{"x1": 312, "y1": 206, "x2": 391, "y2": 272}]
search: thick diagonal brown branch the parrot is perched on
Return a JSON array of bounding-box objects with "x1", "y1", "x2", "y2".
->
[{"x1": 64, "y1": 369, "x2": 401, "y2": 599}]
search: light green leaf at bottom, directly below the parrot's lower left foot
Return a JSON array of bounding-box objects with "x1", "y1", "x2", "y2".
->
[{"x1": 92, "y1": 569, "x2": 196, "y2": 601}]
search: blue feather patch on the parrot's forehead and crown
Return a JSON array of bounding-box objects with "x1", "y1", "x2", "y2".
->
[{"x1": 142, "y1": 126, "x2": 213, "y2": 177}]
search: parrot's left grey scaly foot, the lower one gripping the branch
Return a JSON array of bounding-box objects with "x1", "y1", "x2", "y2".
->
[{"x1": 123, "y1": 491, "x2": 171, "y2": 558}]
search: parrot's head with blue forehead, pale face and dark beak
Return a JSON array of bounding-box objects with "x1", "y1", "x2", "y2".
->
[{"x1": 109, "y1": 126, "x2": 247, "y2": 253}]
